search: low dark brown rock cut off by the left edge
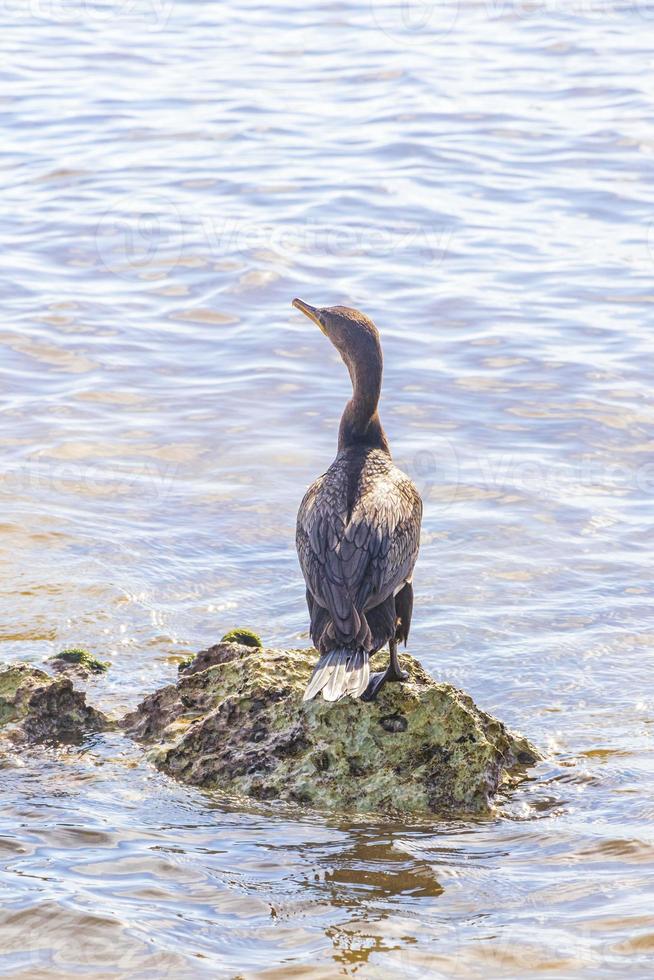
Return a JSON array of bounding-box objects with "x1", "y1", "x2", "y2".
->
[{"x1": 0, "y1": 663, "x2": 110, "y2": 742}]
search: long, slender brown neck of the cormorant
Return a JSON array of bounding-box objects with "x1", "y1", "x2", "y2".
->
[{"x1": 338, "y1": 350, "x2": 390, "y2": 455}]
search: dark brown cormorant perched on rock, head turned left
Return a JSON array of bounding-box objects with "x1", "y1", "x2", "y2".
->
[{"x1": 293, "y1": 299, "x2": 422, "y2": 701}]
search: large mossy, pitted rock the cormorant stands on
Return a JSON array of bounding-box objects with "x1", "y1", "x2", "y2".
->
[{"x1": 122, "y1": 634, "x2": 539, "y2": 817}]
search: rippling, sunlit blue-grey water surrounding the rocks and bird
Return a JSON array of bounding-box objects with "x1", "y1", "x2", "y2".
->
[{"x1": 0, "y1": 0, "x2": 654, "y2": 980}]
